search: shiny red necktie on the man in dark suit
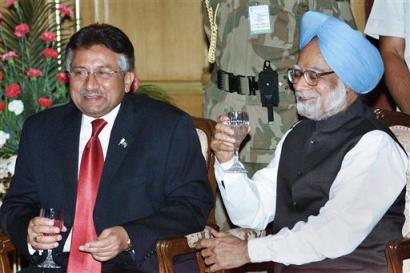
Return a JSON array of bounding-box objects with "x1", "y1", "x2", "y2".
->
[{"x1": 67, "y1": 119, "x2": 107, "y2": 273}]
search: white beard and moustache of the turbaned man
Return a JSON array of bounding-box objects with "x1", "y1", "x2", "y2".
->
[{"x1": 295, "y1": 81, "x2": 347, "y2": 120}]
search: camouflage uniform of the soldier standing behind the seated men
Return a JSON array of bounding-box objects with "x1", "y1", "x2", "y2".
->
[{"x1": 203, "y1": 0, "x2": 355, "y2": 229}]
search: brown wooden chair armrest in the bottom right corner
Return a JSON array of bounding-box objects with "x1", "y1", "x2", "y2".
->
[{"x1": 384, "y1": 238, "x2": 410, "y2": 273}]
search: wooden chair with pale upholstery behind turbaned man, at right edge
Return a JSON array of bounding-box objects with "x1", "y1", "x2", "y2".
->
[{"x1": 374, "y1": 109, "x2": 410, "y2": 273}]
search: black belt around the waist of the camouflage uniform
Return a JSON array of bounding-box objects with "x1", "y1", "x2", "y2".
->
[{"x1": 216, "y1": 69, "x2": 258, "y2": 95}]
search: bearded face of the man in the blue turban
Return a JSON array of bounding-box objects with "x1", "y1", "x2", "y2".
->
[{"x1": 293, "y1": 39, "x2": 357, "y2": 120}]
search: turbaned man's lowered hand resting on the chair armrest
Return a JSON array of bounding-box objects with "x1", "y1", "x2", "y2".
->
[{"x1": 196, "y1": 230, "x2": 250, "y2": 272}]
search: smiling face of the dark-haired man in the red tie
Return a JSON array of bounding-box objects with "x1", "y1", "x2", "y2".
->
[{"x1": 70, "y1": 45, "x2": 135, "y2": 118}]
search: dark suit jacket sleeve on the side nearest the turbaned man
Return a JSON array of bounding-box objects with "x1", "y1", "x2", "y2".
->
[{"x1": 122, "y1": 112, "x2": 213, "y2": 272}]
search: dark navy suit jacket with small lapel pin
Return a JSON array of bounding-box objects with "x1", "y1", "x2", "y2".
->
[{"x1": 1, "y1": 95, "x2": 213, "y2": 272}]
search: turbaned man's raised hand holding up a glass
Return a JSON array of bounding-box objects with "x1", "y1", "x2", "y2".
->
[{"x1": 211, "y1": 116, "x2": 250, "y2": 163}]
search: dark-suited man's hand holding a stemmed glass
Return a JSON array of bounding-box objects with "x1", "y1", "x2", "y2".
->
[{"x1": 27, "y1": 217, "x2": 67, "y2": 250}]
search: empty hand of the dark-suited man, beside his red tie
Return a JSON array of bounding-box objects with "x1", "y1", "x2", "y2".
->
[{"x1": 80, "y1": 226, "x2": 129, "y2": 262}]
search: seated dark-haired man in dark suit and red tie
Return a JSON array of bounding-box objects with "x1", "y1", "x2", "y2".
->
[{"x1": 1, "y1": 24, "x2": 212, "y2": 273}]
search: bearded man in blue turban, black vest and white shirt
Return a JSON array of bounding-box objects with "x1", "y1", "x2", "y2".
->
[{"x1": 198, "y1": 12, "x2": 408, "y2": 273}]
